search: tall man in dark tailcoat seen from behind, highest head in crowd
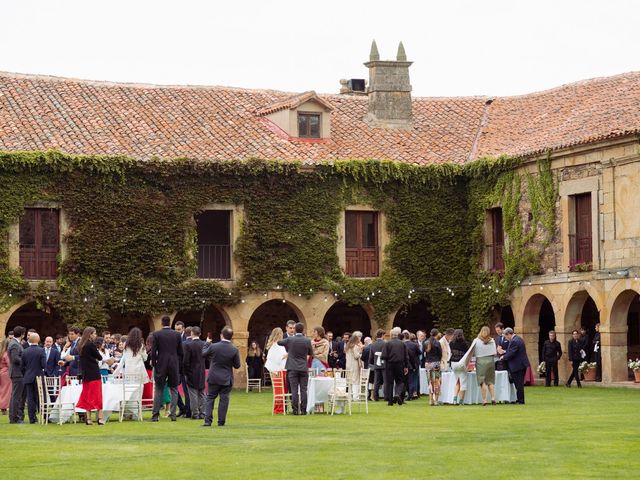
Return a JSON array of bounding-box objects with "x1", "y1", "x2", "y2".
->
[{"x1": 151, "y1": 315, "x2": 183, "y2": 422}]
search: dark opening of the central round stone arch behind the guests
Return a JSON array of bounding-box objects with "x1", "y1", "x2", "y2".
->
[{"x1": 247, "y1": 299, "x2": 305, "y2": 349}]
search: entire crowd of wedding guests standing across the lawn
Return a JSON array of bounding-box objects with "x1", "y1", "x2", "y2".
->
[{"x1": 0, "y1": 317, "x2": 599, "y2": 426}]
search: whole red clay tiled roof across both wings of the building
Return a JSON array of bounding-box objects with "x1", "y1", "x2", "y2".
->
[{"x1": 0, "y1": 69, "x2": 640, "y2": 164}]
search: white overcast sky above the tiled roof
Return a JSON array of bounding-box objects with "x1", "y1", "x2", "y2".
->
[{"x1": 0, "y1": 0, "x2": 640, "y2": 96}]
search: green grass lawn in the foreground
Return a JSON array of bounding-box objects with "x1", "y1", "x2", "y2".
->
[{"x1": 0, "y1": 387, "x2": 640, "y2": 480}]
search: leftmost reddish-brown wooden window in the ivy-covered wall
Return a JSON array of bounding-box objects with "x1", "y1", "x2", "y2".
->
[{"x1": 19, "y1": 208, "x2": 60, "y2": 280}]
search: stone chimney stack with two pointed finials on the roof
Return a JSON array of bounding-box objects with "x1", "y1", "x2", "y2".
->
[{"x1": 364, "y1": 40, "x2": 413, "y2": 128}]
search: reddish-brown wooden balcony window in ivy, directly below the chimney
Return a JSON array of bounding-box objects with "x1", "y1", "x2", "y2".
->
[{"x1": 345, "y1": 211, "x2": 380, "y2": 277}]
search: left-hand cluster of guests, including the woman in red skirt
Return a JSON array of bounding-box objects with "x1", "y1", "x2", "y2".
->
[{"x1": 0, "y1": 316, "x2": 240, "y2": 426}]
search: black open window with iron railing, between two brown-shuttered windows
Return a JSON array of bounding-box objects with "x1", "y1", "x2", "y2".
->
[{"x1": 195, "y1": 210, "x2": 232, "y2": 280}]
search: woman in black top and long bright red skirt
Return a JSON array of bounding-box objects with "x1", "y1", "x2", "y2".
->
[{"x1": 76, "y1": 327, "x2": 104, "y2": 425}]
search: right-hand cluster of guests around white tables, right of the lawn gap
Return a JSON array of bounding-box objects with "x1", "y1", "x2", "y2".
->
[{"x1": 255, "y1": 321, "x2": 529, "y2": 415}]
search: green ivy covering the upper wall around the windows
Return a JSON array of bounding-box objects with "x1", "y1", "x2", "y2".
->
[{"x1": 0, "y1": 152, "x2": 557, "y2": 328}]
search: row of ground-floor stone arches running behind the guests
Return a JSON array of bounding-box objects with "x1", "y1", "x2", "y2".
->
[{"x1": 0, "y1": 278, "x2": 640, "y2": 383}]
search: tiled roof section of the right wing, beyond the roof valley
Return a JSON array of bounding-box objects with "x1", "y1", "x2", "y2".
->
[{"x1": 477, "y1": 72, "x2": 640, "y2": 157}]
